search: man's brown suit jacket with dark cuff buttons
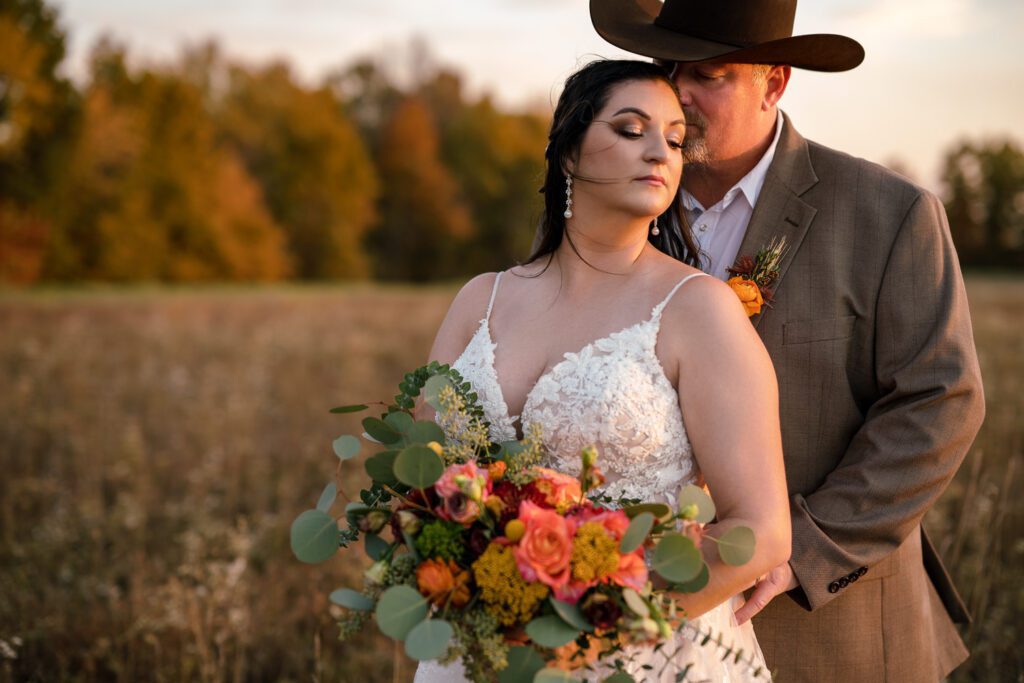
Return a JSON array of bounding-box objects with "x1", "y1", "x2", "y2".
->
[{"x1": 739, "y1": 118, "x2": 984, "y2": 683}]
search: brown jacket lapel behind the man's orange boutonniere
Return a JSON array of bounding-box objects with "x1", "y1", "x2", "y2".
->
[{"x1": 739, "y1": 114, "x2": 818, "y2": 328}]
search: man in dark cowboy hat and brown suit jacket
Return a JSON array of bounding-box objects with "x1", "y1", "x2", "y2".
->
[{"x1": 590, "y1": 0, "x2": 984, "y2": 682}]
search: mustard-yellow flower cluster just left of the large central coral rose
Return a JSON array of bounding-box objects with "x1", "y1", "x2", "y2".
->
[{"x1": 473, "y1": 543, "x2": 548, "y2": 626}]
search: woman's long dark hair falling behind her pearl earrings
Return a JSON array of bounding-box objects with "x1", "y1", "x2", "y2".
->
[{"x1": 525, "y1": 59, "x2": 699, "y2": 267}]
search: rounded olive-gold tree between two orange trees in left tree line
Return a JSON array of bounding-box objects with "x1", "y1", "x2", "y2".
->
[{"x1": 218, "y1": 63, "x2": 378, "y2": 279}]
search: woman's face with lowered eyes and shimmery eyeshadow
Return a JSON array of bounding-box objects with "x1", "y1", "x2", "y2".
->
[{"x1": 572, "y1": 81, "x2": 686, "y2": 218}]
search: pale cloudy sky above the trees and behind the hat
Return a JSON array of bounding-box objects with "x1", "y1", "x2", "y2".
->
[{"x1": 54, "y1": 0, "x2": 1024, "y2": 190}]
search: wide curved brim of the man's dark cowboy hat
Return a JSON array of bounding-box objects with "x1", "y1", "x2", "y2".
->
[{"x1": 590, "y1": 0, "x2": 864, "y2": 72}]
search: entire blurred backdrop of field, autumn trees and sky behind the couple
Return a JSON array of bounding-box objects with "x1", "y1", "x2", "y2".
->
[{"x1": 0, "y1": 0, "x2": 1024, "y2": 681}]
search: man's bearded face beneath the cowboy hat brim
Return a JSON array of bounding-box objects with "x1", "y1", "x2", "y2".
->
[{"x1": 672, "y1": 61, "x2": 765, "y2": 165}]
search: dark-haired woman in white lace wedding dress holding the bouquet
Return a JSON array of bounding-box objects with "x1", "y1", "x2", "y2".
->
[{"x1": 416, "y1": 60, "x2": 790, "y2": 683}]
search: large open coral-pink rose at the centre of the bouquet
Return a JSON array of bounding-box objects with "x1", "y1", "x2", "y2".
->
[{"x1": 515, "y1": 501, "x2": 575, "y2": 589}]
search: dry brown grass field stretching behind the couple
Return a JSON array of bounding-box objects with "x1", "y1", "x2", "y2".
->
[{"x1": 0, "y1": 275, "x2": 1024, "y2": 682}]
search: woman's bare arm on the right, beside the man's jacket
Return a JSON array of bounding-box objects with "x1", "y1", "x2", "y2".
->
[{"x1": 658, "y1": 278, "x2": 791, "y2": 616}]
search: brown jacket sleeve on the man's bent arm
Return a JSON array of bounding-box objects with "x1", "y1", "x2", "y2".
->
[{"x1": 790, "y1": 193, "x2": 984, "y2": 609}]
